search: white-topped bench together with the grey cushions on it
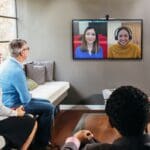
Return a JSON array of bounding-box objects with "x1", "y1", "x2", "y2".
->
[{"x1": 25, "y1": 61, "x2": 70, "y2": 106}]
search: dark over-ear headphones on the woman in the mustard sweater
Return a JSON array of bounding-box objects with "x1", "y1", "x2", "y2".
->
[{"x1": 114, "y1": 26, "x2": 132, "y2": 40}]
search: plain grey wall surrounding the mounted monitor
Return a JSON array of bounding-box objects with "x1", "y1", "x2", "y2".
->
[{"x1": 17, "y1": 0, "x2": 150, "y2": 103}]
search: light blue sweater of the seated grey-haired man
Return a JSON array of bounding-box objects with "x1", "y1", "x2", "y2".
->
[{"x1": 0, "y1": 57, "x2": 31, "y2": 107}]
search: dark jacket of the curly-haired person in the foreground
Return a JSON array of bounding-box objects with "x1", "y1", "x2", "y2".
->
[{"x1": 61, "y1": 135, "x2": 150, "y2": 150}]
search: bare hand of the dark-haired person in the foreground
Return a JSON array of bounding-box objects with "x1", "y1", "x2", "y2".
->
[{"x1": 74, "y1": 130, "x2": 93, "y2": 142}]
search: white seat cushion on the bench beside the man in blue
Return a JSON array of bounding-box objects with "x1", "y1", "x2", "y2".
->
[{"x1": 30, "y1": 81, "x2": 70, "y2": 103}]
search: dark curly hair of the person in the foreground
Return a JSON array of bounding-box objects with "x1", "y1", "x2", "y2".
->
[{"x1": 106, "y1": 86, "x2": 149, "y2": 136}]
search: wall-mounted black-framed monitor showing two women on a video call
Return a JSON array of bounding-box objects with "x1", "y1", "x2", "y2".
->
[{"x1": 72, "y1": 19, "x2": 143, "y2": 60}]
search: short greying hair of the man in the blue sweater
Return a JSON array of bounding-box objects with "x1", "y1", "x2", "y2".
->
[{"x1": 9, "y1": 39, "x2": 27, "y2": 57}]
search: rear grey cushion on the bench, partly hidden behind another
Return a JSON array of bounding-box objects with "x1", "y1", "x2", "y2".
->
[{"x1": 33, "y1": 60, "x2": 54, "y2": 81}]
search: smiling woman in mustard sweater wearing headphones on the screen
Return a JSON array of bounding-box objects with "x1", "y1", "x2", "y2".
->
[{"x1": 108, "y1": 26, "x2": 141, "y2": 58}]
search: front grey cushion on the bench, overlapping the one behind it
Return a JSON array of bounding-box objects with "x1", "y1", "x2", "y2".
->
[{"x1": 26, "y1": 63, "x2": 45, "y2": 84}]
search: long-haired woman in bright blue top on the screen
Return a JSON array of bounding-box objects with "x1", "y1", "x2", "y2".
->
[{"x1": 75, "y1": 27, "x2": 103, "y2": 59}]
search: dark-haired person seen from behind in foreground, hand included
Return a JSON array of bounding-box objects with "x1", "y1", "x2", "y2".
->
[{"x1": 62, "y1": 86, "x2": 150, "y2": 150}]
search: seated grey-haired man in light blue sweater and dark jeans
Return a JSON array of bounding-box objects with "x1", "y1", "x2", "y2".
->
[{"x1": 0, "y1": 39, "x2": 55, "y2": 149}]
